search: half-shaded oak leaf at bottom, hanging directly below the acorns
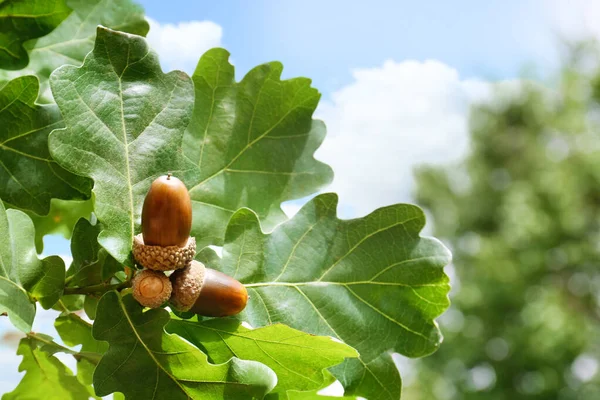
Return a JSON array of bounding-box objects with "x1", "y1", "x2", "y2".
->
[{"x1": 92, "y1": 292, "x2": 277, "y2": 400}]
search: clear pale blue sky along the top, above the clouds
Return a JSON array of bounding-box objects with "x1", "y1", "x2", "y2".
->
[{"x1": 141, "y1": 0, "x2": 554, "y2": 94}]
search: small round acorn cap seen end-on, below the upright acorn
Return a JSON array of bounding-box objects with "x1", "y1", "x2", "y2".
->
[{"x1": 131, "y1": 269, "x2": 173, "y2": 308}]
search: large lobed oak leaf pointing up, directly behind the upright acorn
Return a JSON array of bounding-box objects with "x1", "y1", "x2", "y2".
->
[{"x1": 49, "y1": 27, "x2": 194, "y2": 265}]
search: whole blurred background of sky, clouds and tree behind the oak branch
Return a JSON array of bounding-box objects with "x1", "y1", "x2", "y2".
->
[{"x1": 0, "y1": 0, "x2": 600, "y2": 400}]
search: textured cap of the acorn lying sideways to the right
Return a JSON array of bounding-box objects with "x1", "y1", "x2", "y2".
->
[{"x1": 169, "y1": 260, "x2": 206, "y2": 311}]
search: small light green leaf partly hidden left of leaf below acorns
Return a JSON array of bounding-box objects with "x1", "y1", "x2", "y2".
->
[{"x1": 54, "y1": 313, "x2": 108, "y2": 385}]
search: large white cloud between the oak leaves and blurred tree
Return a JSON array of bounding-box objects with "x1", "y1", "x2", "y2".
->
[{"x1": 316, "y1": 61, "x2": 491, "y2": 217}]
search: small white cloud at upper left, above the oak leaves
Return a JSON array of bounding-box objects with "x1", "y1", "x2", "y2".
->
[{"x1": 147, "y1": 18, "x2": 223, "y2": 75}]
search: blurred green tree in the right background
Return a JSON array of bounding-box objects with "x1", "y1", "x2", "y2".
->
[{"x1": 404, "y1": 45, "x2": 600, "y2": 400}]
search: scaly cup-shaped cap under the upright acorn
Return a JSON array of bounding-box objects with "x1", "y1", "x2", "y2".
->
[{"x1": 133, "y1": 233, "x2": 196, "y2": 271}]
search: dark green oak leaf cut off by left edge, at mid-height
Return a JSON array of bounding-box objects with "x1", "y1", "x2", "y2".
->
[{"x1": 0, "y1": 76, "x2": 92, "y2": 215}]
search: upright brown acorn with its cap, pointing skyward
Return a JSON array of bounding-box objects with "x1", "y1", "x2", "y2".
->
[{"x1": 133, "y1": 174, "x2": 196, "y2": 271}]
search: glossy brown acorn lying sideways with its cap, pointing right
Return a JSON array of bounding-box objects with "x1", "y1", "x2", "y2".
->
[{"x1": 169, "y1": 260, "x2": 248, "y2": 317}]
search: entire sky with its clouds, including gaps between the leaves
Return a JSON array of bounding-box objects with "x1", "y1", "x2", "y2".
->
[{"x1": 0, "y1": 0, "x2": 600, "y2": 393}]
